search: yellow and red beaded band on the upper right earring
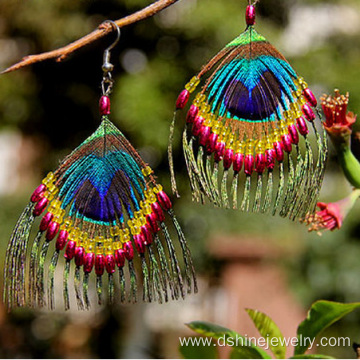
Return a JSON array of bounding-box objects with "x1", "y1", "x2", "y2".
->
[{"x1": 176, "y1": 77, "x2": 317, "y2": 175}]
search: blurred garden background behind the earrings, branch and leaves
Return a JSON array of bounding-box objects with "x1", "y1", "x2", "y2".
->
[{"x1": 0, "y1": 0, "x2": 360, "y2": 358}]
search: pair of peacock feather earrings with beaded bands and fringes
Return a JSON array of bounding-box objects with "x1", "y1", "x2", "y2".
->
[{"x1": 4, "y1": 2, "x2": 327, "y2": 309}]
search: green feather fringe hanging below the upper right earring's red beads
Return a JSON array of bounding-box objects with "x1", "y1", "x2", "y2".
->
[{"x1": 176, "y1": 114, "x2": 328, "y2": 221}]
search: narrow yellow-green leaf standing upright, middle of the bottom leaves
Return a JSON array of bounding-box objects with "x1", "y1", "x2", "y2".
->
[{"x1": 246, "y1": 309, "x2": 286, "y2": 359}]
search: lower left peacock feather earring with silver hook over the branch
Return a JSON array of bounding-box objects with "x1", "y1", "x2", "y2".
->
[{"x1": 4, "y1": 21, "x2": 197, "y2": 309}]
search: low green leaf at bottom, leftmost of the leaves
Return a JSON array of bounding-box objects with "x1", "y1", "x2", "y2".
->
[{"x1": 186, "y1": 321, "x2": 271, "y2": 359}]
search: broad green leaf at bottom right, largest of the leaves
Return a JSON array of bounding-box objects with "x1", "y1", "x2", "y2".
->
[{"x1": 295, "y1": 300, "x2": 360, "y2": 355}]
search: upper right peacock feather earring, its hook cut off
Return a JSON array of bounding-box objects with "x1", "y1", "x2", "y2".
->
[{"x1": 169, "y1": 1, "x2": 327, "y2": 220}]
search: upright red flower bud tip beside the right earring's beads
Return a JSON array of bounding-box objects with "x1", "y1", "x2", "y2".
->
[{"x1": 321, "y1": 89, "x2": 356, "y2": 135}]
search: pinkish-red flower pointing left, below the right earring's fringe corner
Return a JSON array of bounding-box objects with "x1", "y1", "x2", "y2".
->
[{"x1": 304, "y1": 190, "x2": 360, "y2": 231}]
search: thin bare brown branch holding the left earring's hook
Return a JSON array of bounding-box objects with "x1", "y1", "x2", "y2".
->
[{"x1": 1, "y1": 0, "x2": 179, "y2": 74}]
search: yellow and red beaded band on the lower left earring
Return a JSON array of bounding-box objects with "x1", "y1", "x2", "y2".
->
[{"x1": 31, "y1": 172, "x2": 172, "y2": 275}]
